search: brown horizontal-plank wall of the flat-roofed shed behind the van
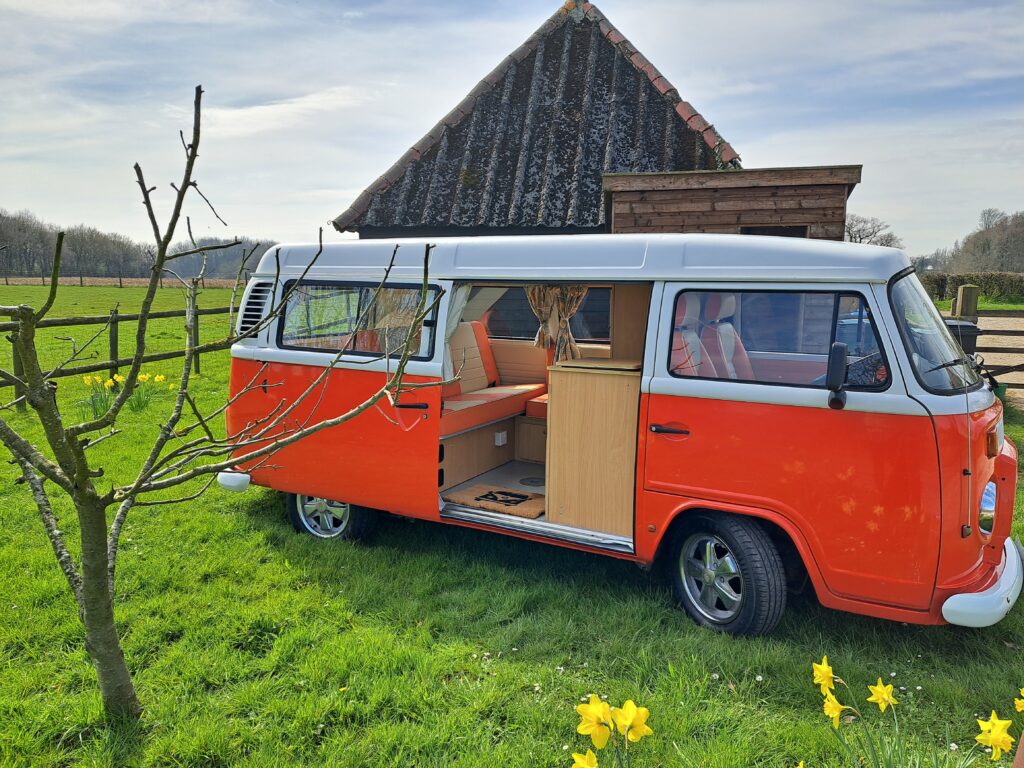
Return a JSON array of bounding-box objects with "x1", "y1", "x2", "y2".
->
[{"x1": 611, "y1": 183, "x2": 848, "y2": 240}]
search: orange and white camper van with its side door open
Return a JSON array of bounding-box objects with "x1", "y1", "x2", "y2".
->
[{"x1": 220, "y1": 234, "x2": 1022, "y2": 634}]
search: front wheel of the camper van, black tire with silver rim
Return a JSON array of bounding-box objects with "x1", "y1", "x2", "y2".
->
[{"x1": 668, "y1": 512, "x2": 786, "y2": 635}]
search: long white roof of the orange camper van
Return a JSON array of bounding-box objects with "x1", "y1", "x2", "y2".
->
[{"x1": 253, "y1": 234, "x2": 910, "y2": 283}]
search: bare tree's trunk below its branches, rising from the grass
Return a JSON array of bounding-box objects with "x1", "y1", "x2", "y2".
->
[{"x1": 76, "y1": 500, "x2": 142, "y2": 718}]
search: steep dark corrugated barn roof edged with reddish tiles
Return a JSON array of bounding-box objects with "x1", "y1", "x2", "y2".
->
[{"x1": 333, "y1": 0, "x2": 739, "y2": 234}]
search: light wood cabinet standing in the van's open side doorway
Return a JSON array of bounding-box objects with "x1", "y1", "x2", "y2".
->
[{"x1": 546, "y1": 358, "x2": 640, "y2": 539}]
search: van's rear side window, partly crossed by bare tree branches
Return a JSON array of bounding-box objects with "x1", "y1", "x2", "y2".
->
[{"x1": 278, "y1": 283, "x2": 436, "y2": 358}]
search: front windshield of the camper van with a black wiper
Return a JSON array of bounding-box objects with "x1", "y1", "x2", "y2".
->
[{"x1": 891, "y1": 273, "x2": 981, "y2": 394}]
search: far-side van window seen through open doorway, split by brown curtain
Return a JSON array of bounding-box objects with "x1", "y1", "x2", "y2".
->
[{"x1": 470, "y1": 287, "x2": 611, "y2": 344}]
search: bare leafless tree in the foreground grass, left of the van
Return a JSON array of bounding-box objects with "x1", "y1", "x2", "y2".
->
[{"x1": 0, "y1": 87, "x2": 446, "y2": 717}]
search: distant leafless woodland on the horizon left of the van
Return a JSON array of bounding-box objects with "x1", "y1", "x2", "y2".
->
[{"x1": 0, "y1": 209, "x2": 273, "y2": 278}]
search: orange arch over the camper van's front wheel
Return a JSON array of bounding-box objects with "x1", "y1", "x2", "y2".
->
[{"x1": 654, "y1": 502, "x2": 827, "y2": 600}]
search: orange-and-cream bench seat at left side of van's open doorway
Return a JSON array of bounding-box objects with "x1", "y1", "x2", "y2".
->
[{"x1": 441, "y1": 321, "x2": 548, "y2": 436}]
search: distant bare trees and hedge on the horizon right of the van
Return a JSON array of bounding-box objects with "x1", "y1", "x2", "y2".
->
[{"x1": 914, "y1": 208, "x2": 1024, "y2": 274}]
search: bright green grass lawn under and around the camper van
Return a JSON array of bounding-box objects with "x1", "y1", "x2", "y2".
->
[{"x1": 0, "y1": 287, "x2": 1024, "y2": 768}]
